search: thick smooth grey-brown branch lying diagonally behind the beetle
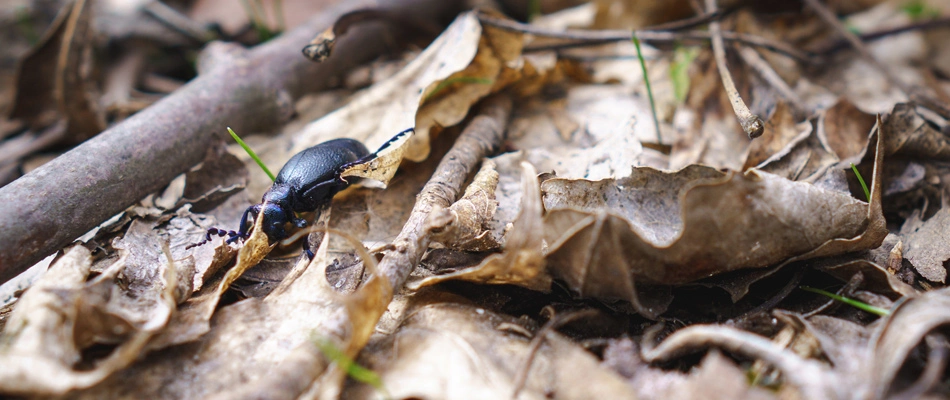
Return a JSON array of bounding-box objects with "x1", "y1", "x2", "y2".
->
[{"x1": 0, "y1": 0, "x2": 462, "y2": 282}]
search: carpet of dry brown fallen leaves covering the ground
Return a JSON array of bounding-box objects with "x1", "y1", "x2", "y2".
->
[{"x1": 0, "y1": 2, "x2": 950, "y2": 399}]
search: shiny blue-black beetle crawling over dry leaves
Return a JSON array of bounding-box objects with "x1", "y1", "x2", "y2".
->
[{"x1": 189, "y1": 128, "x2": 413, "y2": 248}]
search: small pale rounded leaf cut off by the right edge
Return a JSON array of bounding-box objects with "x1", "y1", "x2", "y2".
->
[{"x1": 900, "y1": 199, "x2": 950, "y2": 283}]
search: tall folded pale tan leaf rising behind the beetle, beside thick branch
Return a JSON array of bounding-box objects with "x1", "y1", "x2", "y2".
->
[{"x1": 292, "y1": 13, "x2": 521, "y2": 161}]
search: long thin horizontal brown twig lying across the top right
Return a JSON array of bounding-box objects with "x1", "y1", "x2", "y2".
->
[{"x1": 478, "y1": 14, "x2": 814, "y2": 64}]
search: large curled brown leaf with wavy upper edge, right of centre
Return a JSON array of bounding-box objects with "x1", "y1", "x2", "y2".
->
[{"x1": 541, "y1": 119, "x2": 887, "y2": 315}]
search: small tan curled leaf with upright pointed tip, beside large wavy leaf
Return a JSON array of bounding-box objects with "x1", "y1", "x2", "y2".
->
[{"x1": 408, "y1": 162, "x2": 551, "y2": 292}]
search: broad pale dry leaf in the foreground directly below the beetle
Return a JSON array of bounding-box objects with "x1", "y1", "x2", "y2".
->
[{"x1": 66, "y1": 230, "x2": 391, "y2": 399}]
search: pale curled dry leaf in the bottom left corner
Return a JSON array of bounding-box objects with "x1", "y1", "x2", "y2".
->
[{"x1": 0, "y1": 236, "x2": 182, "y2": 395}]
